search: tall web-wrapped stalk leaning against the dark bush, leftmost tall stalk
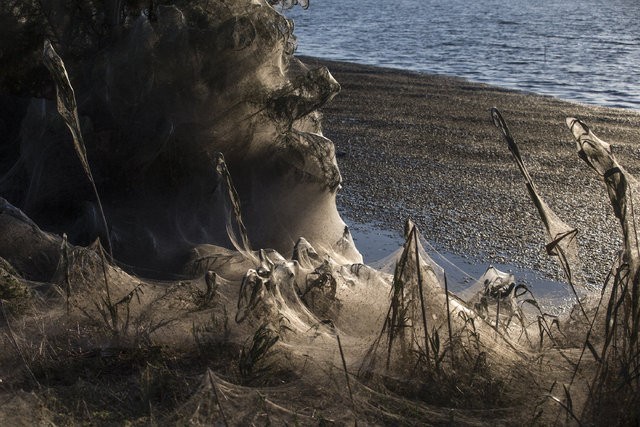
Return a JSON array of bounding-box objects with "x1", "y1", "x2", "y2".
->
[{"x1": 43, "y1": 40, "x2": 113, "y2": 259}]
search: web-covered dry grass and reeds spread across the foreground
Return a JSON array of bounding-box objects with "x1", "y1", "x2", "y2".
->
[{"x1": 0, "y1": 93, "x2": 640, "y2": 425}]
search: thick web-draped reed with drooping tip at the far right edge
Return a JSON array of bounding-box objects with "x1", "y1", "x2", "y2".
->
[{"x1": 566, "y1": 117, "x2": 640, "y2": 424}]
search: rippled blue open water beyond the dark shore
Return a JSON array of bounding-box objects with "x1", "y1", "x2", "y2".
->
[{"x1": 286, "y1": 0, "x2": 640, "y2": 110}]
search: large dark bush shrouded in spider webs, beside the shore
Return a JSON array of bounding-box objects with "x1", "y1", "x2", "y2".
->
[{"x1": 0, "y1": 0, "x2": 361, "y2": 271}]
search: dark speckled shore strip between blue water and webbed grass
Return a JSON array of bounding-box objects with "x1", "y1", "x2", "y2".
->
[{"x1": 303, "y1": 58, "x2": 640, "y2": 283}]
